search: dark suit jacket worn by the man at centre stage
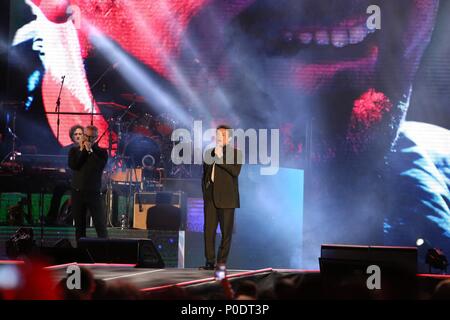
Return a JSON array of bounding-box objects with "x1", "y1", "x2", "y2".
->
[{"x1": 202, "y1": 147, "x2": 242, "y2": 209}]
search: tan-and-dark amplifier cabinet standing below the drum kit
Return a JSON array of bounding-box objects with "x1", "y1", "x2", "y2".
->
[{"x1": 133, "y1": 191, "x2": 186, "y2": 231}]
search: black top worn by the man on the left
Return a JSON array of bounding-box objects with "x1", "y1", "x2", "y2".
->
[{"x1": 69, "y1": 144, "x2": 108, "y2": 191}]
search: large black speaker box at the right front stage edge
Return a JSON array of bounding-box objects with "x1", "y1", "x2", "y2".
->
[{"x1": 319, "y1": 245, "x2": 417, "y2": 299}]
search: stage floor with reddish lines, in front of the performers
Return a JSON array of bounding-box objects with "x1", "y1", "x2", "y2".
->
[{"x1": 0, "y1": 260, "x2": 450, "y2": 299}]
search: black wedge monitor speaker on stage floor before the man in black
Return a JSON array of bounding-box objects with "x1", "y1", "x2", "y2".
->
[{"x1": 78, "y1": 238, "x2": 165, "y2": 268}]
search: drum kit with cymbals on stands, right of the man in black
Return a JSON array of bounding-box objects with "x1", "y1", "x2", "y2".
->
[{"x1": 99, "y1": 94, "x2": 192, "y2": 225}]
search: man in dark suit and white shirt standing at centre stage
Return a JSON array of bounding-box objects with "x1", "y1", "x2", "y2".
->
[{"x1": 200, "y1": 125, "x2": 242, "y2": 270}]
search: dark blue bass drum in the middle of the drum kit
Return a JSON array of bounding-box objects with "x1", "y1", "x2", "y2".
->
[{"x1": 123, "y1": 134, "x2": 161, "y2": 168}]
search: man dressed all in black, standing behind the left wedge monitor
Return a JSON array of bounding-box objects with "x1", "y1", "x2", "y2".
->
[{"x1": 69, "y1": 126, "x2": 108, "y2": 242}]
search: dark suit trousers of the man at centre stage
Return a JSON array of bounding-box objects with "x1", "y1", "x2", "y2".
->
[{"x1": 203, "y1": 183, "x2": 234, "y2": 264}]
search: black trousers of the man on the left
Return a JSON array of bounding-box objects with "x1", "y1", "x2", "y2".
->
[{"x1": 72, "y1": 189, "x2": 108, "y2": 242}]
